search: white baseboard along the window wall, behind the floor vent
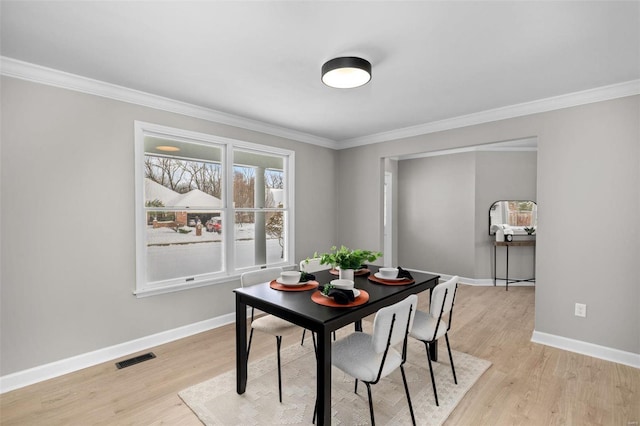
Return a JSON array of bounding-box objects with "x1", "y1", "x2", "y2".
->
[{"x1": 0, "y1": 313, "x2": 236, "y2": 394}]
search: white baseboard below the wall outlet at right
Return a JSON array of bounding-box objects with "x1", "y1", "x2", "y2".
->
[{"x1": 531, "y1": 330, "x2": 640, "y2": 368}]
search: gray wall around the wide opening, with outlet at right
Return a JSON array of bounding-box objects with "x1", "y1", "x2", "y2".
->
[{"x1": 338, "y1": 96, "x2": 640, "y2": 353}]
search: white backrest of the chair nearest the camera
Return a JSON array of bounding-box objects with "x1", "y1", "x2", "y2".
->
[{"x1": 373, "y1": 294, "x2": 418, "y2": 353}]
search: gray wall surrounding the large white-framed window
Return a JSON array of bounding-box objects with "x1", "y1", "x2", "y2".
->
[{"x1": 0, "y1": 77, "x2": 336, "y2": 375}]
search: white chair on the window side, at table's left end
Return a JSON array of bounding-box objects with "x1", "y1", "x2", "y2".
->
[{"x1": 240, "y1": 267, "x2": 298, "y2": 402}]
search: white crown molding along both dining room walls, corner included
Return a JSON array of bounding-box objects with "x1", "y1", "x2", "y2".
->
[{"x1": 0, "y1": 56, "x2": 640, "y2": 150}]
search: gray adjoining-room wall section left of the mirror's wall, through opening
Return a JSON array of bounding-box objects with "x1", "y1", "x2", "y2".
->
[{"x1": 397, "y1": 153, "x2": 475, "y2": 277}]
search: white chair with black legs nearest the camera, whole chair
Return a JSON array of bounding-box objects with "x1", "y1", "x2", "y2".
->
[{"x1": 314, "y1": 294, "x2": 418, "y2": 425}]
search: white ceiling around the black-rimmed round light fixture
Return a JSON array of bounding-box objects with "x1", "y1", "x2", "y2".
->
[{"x1": 0, "y1": 0, "x2": 640, "y2": 144}]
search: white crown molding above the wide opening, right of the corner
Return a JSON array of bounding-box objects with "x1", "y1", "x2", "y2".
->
[{"x1": 338, "y1": 80, "x2": 640, "y2": 149}]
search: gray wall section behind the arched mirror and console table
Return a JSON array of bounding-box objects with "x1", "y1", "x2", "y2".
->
[{"x1": 471, "y1": 151, "x2": 538, "y2": 279}]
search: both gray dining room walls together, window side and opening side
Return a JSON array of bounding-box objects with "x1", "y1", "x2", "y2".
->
[{"x1": 0, "y1": 77, "x2": 640, "y2": 375}]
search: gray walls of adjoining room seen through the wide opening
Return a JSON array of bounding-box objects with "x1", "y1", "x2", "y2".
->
[{"x1": 397, "y1": 151, "x2": 536, "y2": 279}]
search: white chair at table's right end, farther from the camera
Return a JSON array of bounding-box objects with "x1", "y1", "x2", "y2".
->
[{"x1": 410, "y1": 276, "x2": 459, "y2": 405}]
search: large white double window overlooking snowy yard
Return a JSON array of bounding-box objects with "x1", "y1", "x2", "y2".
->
[{"x1": 135, "y1": 122, "x2": 294, "y2": 296}]
